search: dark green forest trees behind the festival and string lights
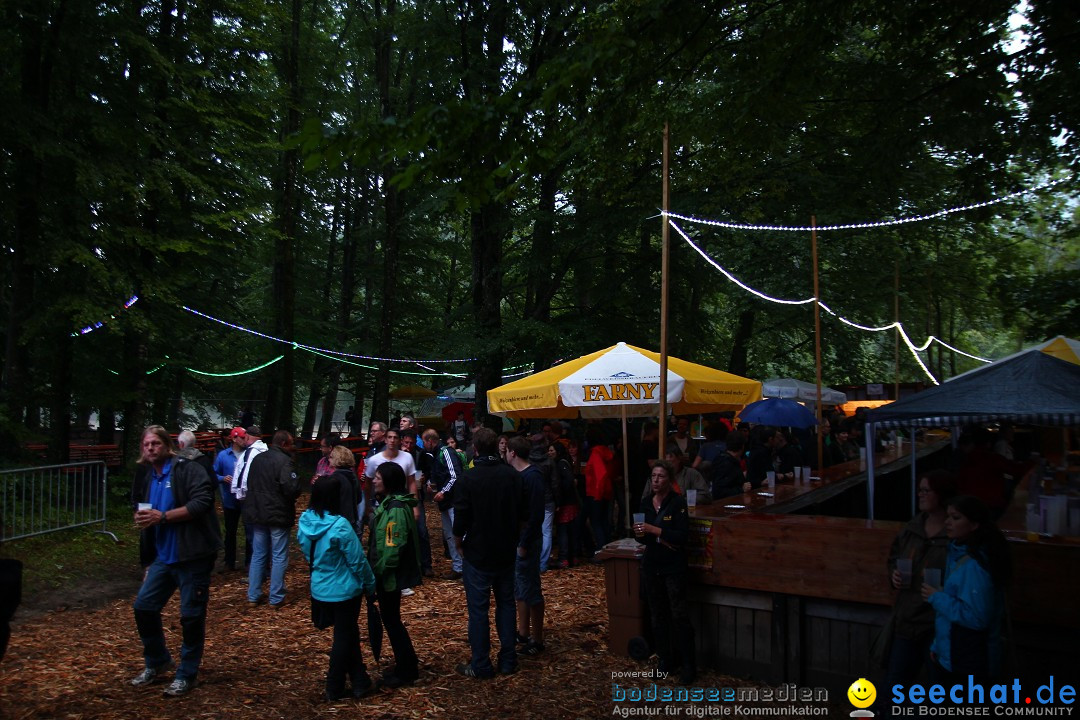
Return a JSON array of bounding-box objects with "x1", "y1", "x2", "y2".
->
[{"x1": 0, "y1": 0, "x2": 1080, "y2": 460}]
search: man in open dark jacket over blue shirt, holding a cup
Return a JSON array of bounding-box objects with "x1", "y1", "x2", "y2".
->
[{"x1": 131, "y1": 425, "x2": 221, "y2": 697}]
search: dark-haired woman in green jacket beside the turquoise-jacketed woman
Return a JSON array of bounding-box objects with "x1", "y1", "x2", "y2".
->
[{"x1": 372, "y1": 462, "x2": 422, "y2": 688}]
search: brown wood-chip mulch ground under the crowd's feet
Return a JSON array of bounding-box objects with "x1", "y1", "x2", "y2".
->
[{"x1": 0, "y1": 501, "x2": 743, "y2": 720}]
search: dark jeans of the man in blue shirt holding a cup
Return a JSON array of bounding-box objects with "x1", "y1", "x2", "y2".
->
[{"x1": 134, "y1": 555, "x2": 215, "y2": 681}]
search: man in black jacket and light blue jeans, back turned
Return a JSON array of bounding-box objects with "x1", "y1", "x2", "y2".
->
[{"x1": 243, "y1": 430, "x2": 300, "y2": 610}]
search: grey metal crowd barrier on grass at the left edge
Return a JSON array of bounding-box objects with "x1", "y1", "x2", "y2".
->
[{"x1": 0, "y1": 460, "x2": 119, "y2": 542}]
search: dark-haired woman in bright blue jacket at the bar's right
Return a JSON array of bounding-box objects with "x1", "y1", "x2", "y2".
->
[{"x1": 922, "y1": 495, "x2": 1012, "y2": 685}]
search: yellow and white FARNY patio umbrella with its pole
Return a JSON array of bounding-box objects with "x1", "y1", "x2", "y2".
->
[{"x1": 487, "y1": 342, "x2": 761, "y2": 527}]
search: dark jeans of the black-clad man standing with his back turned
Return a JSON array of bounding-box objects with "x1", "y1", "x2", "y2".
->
[{"x1": 461, "y1": 558, "x2": 517, "y2": 677}]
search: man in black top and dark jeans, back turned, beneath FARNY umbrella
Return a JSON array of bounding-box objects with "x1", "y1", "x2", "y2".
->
[{"x1": 454, "y1": 427, "x2": 527, "y2": 678}]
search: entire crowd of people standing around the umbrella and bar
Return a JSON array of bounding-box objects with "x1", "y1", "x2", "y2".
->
[{"x1": 124, "y1": 415, "x2": 1009, "y2": 701}]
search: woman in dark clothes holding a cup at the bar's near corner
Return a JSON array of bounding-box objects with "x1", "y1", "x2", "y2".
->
[{"x1": 634, "y1": 460, "x2": 697, "y2": 684}]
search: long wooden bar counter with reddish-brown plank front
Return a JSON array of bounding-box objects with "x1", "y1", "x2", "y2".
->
[{"x1": 673, "y1": 448, "x2": 1080, "y2": 690}]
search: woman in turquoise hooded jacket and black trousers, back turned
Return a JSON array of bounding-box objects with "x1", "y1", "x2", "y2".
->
[{"x1": 296, "y1": 475, "x2": 375, "y2": 702}]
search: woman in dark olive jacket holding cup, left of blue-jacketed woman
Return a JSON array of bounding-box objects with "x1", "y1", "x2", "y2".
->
[{"x1": 878, "y1": 470, "x2": 956, "y2": 688}]
